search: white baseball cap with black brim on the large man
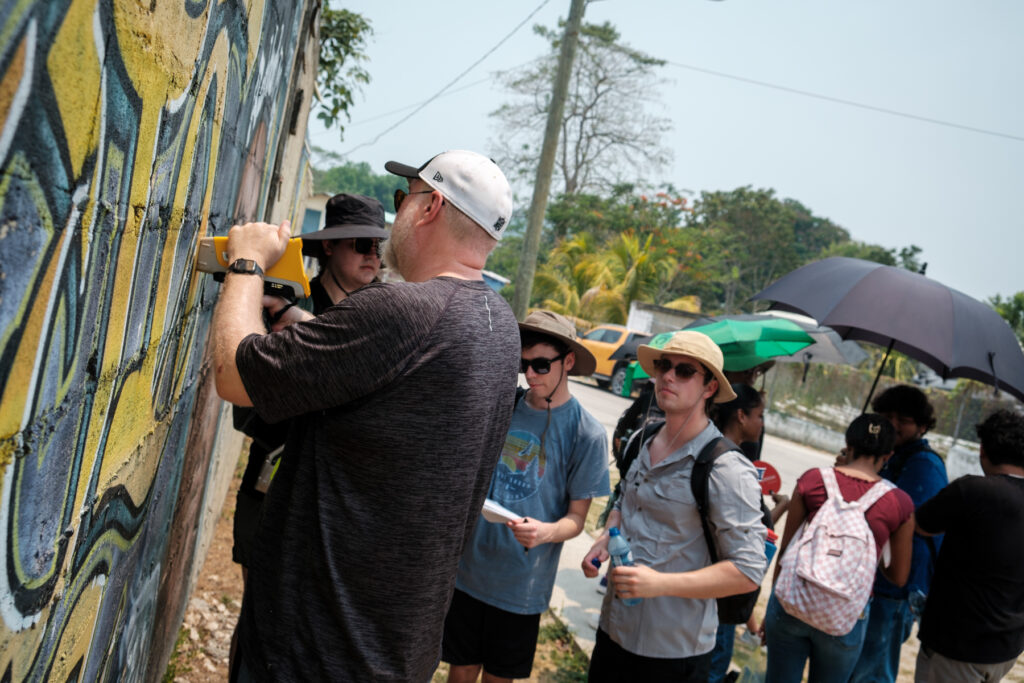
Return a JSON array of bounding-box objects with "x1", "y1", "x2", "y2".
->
[{"x1": 384, "y1": 150, "x2": 512, "y2": 240}]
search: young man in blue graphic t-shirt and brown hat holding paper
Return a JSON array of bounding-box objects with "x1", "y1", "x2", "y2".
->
[{"x1": 441, "y1": 310, "x2": 609, "y2": 682}]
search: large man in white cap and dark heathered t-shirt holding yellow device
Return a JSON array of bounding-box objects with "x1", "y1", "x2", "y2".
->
[{"x1": 212, "y1": 152, "x2": 519, "y2": 681}]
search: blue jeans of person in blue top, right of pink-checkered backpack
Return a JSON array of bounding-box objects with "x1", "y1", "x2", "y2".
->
[{"x1": 850, "y1": 595, "x2": 913, "y2": 683}]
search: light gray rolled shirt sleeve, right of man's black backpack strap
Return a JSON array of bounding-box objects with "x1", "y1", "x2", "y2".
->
[{"x1": 708, "y1": 451, "x2": 767, "y2": 584}]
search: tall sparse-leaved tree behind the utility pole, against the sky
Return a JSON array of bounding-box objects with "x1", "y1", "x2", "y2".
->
[{"x1": 492, "y1": 22, "x2": 671, "y2": 196}]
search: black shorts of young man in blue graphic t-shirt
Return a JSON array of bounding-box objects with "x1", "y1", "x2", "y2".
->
[{"x1": 441, "y1": 589, "x2": 541, "y2": 678}]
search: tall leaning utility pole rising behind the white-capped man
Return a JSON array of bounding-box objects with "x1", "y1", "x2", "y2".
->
[{"x1": 512, "y1": 0, "x2": 586, "y2": 321}]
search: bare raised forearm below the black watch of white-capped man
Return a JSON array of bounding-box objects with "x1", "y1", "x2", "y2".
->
[{"x1": 210, "y1": 272, "x2": 265, "y2": 405}]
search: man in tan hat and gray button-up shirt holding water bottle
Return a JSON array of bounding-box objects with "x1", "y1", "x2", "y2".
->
[{"x1": 583, "y1": 332, "x2": 767, "y2": 681}]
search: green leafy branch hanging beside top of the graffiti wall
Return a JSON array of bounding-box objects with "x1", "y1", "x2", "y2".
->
[{"x1": 316, "y1": 0, "x2": 373, "y2": 132}]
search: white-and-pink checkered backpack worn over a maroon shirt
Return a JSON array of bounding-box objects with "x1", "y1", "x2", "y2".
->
[{"x1": 775, "y1": 467, "x2": 896, "y2": 636}]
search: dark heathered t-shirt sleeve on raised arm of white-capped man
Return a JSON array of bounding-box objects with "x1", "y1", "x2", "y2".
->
[{"x1": 236, "y1": 285, "x2": 437, "y2": 422}]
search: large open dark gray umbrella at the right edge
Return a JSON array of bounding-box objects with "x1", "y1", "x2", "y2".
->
[{"x1": 752, "y1": 256, "x2": 1024, "y2": 400}]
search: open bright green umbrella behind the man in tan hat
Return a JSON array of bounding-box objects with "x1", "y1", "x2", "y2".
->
[{"x1": 634, "y1": 318, "x2": 814, "y2": 378}]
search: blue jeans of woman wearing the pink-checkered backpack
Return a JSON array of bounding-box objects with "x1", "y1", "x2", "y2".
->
[{"x1": 765, "y1": 593, "x2": 867, "y2": 683}]
